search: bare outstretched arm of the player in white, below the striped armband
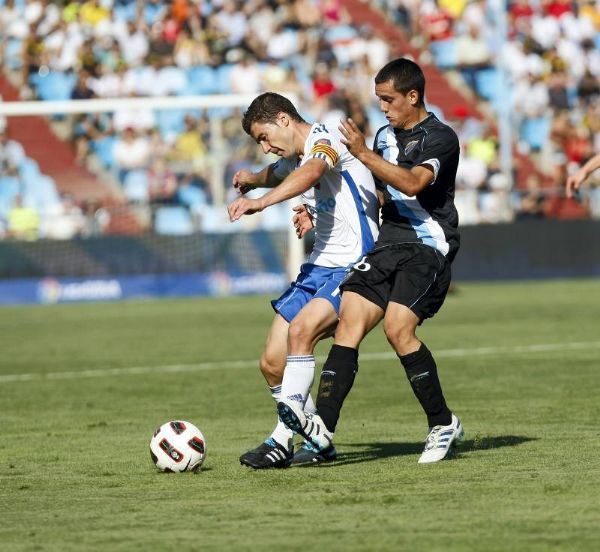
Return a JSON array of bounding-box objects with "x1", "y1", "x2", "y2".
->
[{"x1": 227, "y1": 158, "x2": 329, "y2": 222}]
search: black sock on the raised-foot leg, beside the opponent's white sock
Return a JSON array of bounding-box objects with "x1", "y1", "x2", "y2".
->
[{"x1": 317, "y1": 345, "x2": 358, "y2": 432}]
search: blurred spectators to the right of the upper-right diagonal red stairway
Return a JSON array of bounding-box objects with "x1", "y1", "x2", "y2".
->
[{"x1": 374, "y1": 0, "x2": 600, "y2": 223}]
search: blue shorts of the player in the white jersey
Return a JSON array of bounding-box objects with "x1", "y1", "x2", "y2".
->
[{"x1": 271, "y1": 263, "x2": 351, "y2": 322}]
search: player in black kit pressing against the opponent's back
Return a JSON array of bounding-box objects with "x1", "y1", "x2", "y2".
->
[{"x1": 278, "y1": 58, "x2": 464, "y2": 464}]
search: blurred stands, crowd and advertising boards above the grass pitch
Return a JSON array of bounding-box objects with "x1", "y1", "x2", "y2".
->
[{"x1": 0, "y1": 0, "x2": 600, "y2": 303}]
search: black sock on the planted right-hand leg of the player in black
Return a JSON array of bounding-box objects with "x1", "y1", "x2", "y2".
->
[{"x1": 398, "y1": 343, "x2": 452, "y2": 427}]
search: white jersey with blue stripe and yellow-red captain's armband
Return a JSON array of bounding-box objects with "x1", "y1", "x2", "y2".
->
[{"x1": 273, "y1": 123, "x2": 379, "y2": 267}]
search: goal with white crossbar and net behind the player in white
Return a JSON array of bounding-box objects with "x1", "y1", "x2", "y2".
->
[{"x1": 0, "y1": 95, "x2": 304, "y2": 303}]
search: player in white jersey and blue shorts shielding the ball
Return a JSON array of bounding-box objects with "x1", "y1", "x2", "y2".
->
[{"x1": 228, "y1": 92, "x2": 379, "y2": 469}]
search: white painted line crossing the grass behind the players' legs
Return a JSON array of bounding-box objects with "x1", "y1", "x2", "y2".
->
[{"x1": 0, "y1": 341, "x2": 600, "y2": 384}]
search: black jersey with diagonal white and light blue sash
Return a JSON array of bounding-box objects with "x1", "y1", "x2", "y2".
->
[{"x1": 374, "y1": 113, "x2": 460, "y2": 261}]
